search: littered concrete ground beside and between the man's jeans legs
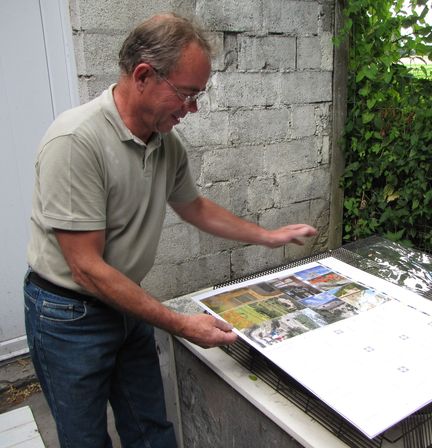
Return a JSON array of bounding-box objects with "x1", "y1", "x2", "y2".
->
[{"x1": 0, "y1": 357, "x2": 121, "y2": 448}]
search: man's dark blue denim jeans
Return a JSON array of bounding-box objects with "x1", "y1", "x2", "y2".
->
[{"x1": 24, "y1": 276, "x2": 176, "y2": 448}]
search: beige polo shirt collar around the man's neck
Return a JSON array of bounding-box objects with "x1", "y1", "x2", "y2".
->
[{"x1": 101, "y1": 84, "x2": 161, "y2": 152}]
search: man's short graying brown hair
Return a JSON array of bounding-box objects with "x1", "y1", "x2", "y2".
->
[{"x1": 119, "y1": 13, "x2": 212, "y2": 76}]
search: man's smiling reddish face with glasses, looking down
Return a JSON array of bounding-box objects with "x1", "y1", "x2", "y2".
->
[{"x1": 143, "y1": 43, "x2": 211, "y2": 132}]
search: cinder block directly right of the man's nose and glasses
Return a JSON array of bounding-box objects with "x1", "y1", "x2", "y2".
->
[{"x1": 212, "y1": 72, "x2": 280, "y2": 108}]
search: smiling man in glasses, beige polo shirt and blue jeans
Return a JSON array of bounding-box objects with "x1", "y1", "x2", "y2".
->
[{"x1": 24, "y1": 14, "x2": 316, "y2": 448}]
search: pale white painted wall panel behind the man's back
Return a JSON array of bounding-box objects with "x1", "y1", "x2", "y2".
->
[{"x1": 0, "y1": 0, "x2": 78, "y2": 360}]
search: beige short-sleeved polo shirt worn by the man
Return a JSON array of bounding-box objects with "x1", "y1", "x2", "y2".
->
[{"x1": 28, "y1": 85, "x2": 198, "y2": 292}]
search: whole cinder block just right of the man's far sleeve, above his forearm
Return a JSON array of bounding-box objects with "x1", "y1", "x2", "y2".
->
[{"x1": 201, "y1": 146, "x2": 263, "y2": 183}]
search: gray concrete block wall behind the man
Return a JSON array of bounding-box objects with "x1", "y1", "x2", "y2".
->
[{"x1": 70, "y1": 0, "x2": 337, "y2": 300}]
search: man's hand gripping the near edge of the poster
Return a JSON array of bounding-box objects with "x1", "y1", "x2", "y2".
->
[{"x1": 178, "y1": 313, "x2": 237, "y2": 348}]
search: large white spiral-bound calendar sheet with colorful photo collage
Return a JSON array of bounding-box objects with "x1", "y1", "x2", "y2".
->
[{"x1": 194, "y1": 257, "x2": 432, "y2": 438}]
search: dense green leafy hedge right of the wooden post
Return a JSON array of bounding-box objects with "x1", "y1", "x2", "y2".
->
[{"x1": 336, "y1": 0, "x2": 432, "y2": 251}]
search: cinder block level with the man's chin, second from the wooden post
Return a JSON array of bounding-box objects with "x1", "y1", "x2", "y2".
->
[{"x1": 229, "y1": 109, "x2": 290, "y2": 145}]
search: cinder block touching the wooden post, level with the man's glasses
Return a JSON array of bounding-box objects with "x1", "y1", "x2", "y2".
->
[{"x1": 281, "y1": 71, "x2": 332, "y2": 104}]
